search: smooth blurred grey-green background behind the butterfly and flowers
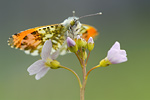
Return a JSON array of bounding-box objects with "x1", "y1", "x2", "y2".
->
[{"x1": 0, "y1": 0, "x2": 150, "y2": 100}]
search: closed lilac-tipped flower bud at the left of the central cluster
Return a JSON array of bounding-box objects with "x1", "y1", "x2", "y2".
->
[{"x1": 67, "y1": 37, "x2": 78, "y2": 52}]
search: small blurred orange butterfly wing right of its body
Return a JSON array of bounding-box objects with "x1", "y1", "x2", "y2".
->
[{"x1": 80, "y1": 24, "x2": 98, "y2": 41}]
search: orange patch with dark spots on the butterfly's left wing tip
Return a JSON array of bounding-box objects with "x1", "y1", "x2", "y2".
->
[{"x1": 8, "y1": 29, "x2": 41, "y2": 50}]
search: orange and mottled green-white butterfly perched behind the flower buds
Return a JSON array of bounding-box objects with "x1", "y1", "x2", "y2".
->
[{"x1": 8, "y1": 12, "x2": 101, "y2": 56}]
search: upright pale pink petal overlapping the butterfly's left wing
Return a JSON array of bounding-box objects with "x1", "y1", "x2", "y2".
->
[{"x1": 41, "y1": 39, "x2": 52, "y2": 60}]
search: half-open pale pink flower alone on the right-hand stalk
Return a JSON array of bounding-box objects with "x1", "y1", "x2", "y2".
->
[{"x1": 100, "y1": 41, "x2": 127, "y2": 67}]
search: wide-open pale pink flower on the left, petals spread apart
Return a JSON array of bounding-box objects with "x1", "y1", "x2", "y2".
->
[{"x1": 27, "y1": 40, "x2": 59, "y2": 80}]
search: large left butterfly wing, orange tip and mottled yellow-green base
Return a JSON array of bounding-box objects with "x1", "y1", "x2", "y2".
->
[{"x1": 8, "y1": 24, "x2": 65, "y2": 55}]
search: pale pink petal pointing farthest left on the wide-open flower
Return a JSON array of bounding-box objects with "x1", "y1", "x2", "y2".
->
[{"x1": 27, "y1": 60, "x2": 44, "y2": 75}]
